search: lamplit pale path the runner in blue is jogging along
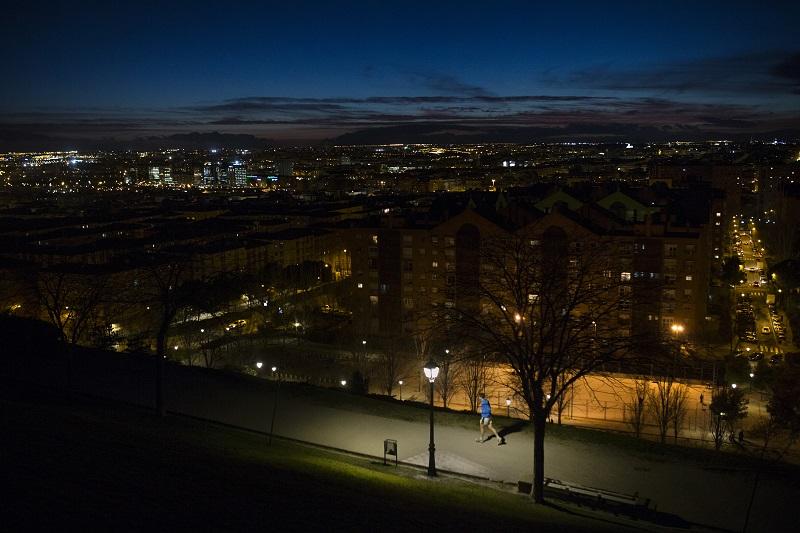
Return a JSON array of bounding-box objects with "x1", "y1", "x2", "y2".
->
[{"x1": 7, "y1": 356, "x2": 800, "y2": 531}]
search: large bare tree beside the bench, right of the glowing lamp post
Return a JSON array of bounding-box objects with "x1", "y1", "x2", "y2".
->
[{"x1": 447, "y1": 224, "x2": 649, "y2": 502}]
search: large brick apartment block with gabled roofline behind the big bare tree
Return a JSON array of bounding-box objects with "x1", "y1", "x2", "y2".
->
[{"x1": 348, "y1": 191, "x2": 714, "y2": 337}]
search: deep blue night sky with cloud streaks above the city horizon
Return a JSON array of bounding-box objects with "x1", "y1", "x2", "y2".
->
[{"x1": 0, "y1": 0, "x2": 800, "y2": 145}]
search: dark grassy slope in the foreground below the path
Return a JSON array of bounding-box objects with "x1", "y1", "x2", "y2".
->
[{"x1": 0, "y1": 382, "x2": 630, "y2": 531}]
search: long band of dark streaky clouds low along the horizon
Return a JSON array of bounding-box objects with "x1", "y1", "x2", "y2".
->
[{"x1": 0, "y1": 89, "x2": 800, "y2": 148}]
